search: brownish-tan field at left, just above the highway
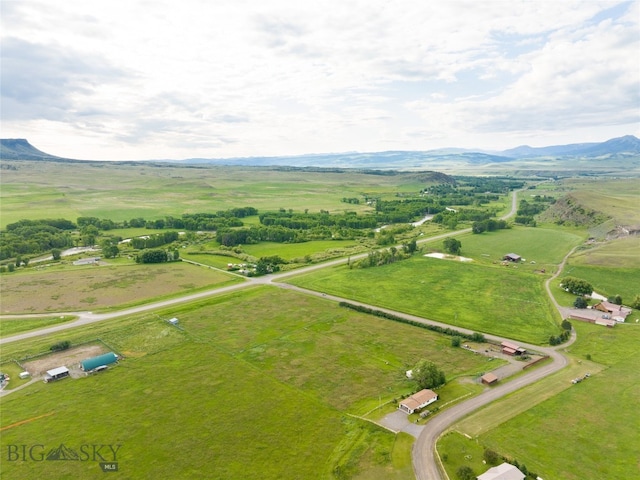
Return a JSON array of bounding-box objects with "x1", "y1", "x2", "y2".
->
[{"x1": 2, "y1": 262, "x2": 242, "y2": 314}]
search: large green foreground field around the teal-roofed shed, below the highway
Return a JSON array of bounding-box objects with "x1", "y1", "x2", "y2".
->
[{"x1": 0, "y1": 287, "x2": 486, "y2": 479}]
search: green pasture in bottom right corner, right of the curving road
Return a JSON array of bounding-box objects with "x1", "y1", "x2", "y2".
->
[{"x1": 480, "y1": 324, "x2": 640, "y2": 480}]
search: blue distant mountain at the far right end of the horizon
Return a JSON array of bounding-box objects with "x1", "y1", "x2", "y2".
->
[{"x1": 500, "y1": 135, "x2": 640, "y2": 159}]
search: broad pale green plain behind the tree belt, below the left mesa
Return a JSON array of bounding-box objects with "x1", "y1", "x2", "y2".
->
[{"x1": 0, "y1": 161, "x2": 444, "y2": 228}]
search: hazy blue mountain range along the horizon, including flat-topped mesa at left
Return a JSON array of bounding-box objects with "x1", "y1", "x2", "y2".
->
[{"x1": 0, "y1": 135, "x2": 640, "y2": 169}]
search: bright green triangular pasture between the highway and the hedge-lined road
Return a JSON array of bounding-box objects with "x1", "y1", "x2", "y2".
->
[{"x1": 287, "y1": 255, "x2": 560, "y2": 343}]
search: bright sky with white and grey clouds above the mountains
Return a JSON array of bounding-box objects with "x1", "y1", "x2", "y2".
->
[{"x1": 0, "y1": 0, "x2": 640, "y2": 160}]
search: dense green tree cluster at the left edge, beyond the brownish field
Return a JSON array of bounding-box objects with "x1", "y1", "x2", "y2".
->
[{"x1": 0, "y1": 218, "x2": 77, "y2": 260}]
